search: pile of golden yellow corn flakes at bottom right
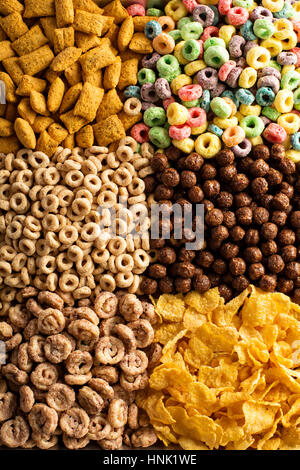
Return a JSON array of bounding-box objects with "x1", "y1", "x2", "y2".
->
[{"x1": 137, "y1": 286, "x2": 300, "y2": 450}]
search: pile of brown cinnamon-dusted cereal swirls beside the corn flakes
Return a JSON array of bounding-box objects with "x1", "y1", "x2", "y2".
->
[{"x1": 0, "y1": 287, "x2": 161, "y2": 450}]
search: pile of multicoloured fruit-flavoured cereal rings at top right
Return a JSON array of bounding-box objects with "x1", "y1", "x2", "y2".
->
[{"x1": 128, "y1": 0, "x2": 300, "y2": 159}]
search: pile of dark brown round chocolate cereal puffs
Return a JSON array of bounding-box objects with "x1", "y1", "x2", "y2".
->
[{"x1": 141, "y1": 144, "x2": 300, "y2": 303}]
